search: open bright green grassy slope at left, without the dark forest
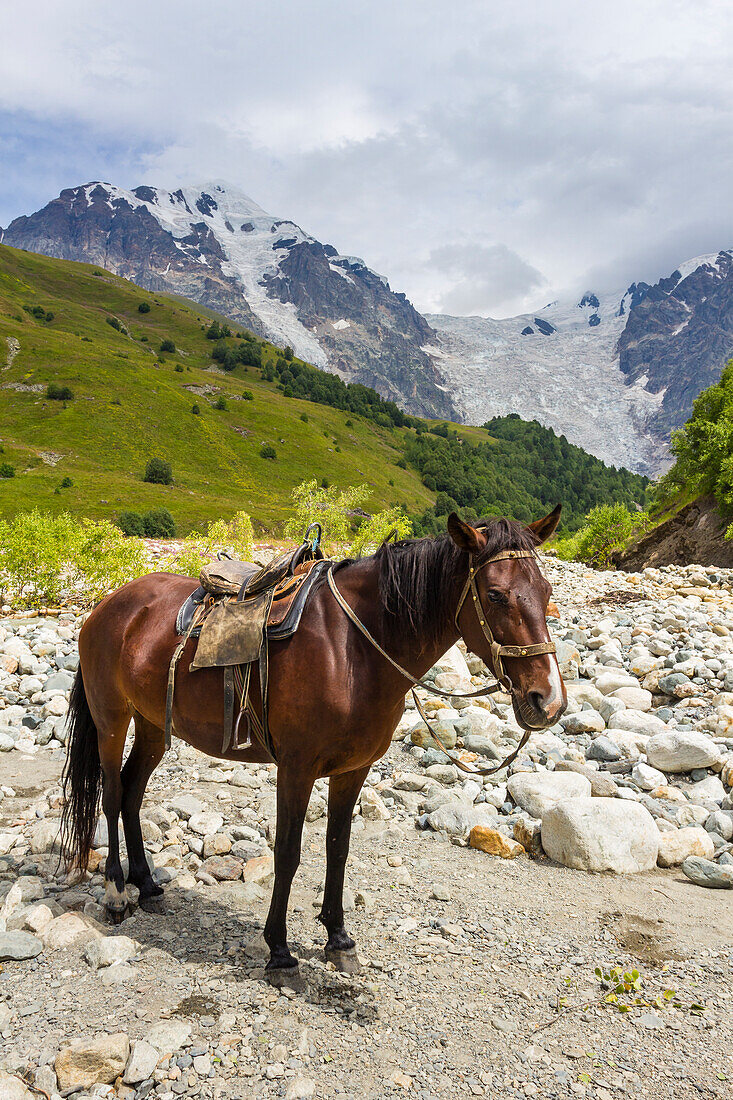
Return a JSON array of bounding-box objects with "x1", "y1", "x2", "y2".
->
[{"x1": 0, "y1": 245, "x2": 433, "y2": 530}]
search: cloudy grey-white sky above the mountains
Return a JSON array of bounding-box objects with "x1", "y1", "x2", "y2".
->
[{"x1": 0, "y1": 0, "x2": 733, "y2": 317}]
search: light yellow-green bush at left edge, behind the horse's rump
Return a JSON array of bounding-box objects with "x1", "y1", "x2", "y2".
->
[{"x1": 0, "y1": 509, "x2": 149, "y2": 607}]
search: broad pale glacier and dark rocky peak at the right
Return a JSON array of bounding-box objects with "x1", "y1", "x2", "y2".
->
[{"x1": 427, "y1": 252, "x2": 733, "y2": 474}]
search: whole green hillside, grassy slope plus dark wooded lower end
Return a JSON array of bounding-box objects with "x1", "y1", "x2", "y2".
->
[{"x1": 0, "y1": 245, "x2": 646, "y2": 534}]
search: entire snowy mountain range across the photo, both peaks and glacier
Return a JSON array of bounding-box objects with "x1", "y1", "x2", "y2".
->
[{"x1": 0, "y1": 182, "x2": 733, "y2": 474}]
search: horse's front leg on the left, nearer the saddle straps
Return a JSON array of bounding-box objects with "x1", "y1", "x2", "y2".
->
[{"x1": 264, "y1": 765, "x2": 315, "y2": 985}]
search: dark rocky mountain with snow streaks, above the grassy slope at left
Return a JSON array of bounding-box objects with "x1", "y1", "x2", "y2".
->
[{"x1": 0, "y1": 182, "x2": 456, "y2": 417}]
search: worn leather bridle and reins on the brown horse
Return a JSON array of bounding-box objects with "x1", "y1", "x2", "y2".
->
[{"x1": 326, "y1": 550, "x2": 556, "y2": 776}]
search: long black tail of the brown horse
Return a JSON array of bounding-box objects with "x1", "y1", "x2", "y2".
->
[{"x1": 61, "y1": 664, "x2": 101, "y2": 870}]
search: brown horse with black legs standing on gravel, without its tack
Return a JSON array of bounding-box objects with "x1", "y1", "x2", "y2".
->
[{"x1": 63, "y1": 505, "x2": 567, "y2": 981}]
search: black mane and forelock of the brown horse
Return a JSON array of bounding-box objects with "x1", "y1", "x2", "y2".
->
[{"x1": 374, "y1": 519, "x2": 537, "y2": 644}]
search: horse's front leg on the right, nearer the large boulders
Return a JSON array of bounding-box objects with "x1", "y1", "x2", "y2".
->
[{"x1": 318, "y1": 767, "x2": 369, "y2": 974}]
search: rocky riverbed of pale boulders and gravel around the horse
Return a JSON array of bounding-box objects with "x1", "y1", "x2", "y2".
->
[{"x1": 0, "y1": 559, "x2": 733, "y2": 1100}]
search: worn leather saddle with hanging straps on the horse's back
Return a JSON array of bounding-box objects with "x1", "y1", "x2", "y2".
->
[{"x1": 165, "y1": 524, "x2": 331, "y2": 760}]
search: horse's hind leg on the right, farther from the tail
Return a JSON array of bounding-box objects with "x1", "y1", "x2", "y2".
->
[{"x1": 122, "y1": 714, "x2": 165, "y2": 909}]
